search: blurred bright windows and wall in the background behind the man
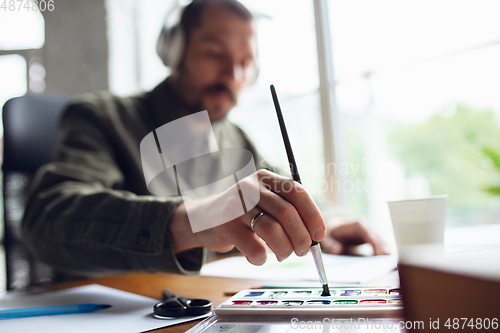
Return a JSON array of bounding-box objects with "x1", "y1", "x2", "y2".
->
[{"x1": 0, "y1": 0, "x2": 500, "y2": 285}]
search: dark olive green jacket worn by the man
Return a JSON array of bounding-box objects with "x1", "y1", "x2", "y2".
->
[{"x1": 23, "y1": 79, "x2": 263, "y2": 276}]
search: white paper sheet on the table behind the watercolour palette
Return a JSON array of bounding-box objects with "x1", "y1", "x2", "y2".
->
[{"x1": 201, "y1": 253, "x2": 397, "y2": 283}]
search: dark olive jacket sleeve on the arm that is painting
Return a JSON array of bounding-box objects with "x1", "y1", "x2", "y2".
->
[{"x1": 23, "y1": 97, "x2": 205, "y2": 276}]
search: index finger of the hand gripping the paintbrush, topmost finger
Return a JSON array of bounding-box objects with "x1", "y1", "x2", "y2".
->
[{"x1": 257, "y1": 170, "x2": 326, "y2": 241}]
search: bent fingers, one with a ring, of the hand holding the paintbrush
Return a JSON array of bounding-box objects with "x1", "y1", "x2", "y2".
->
[{"x1": 213, "y1": 170, "x2": 326, "y2": 265}]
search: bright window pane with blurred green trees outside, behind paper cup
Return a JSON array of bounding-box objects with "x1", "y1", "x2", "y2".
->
[{"x1": 328, "y1": 0, "x2": 500, "y2": 228}]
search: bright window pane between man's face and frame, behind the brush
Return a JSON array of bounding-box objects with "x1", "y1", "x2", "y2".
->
[{"x1": 229, "y1": 0, "x2": 324, "y2": 198}]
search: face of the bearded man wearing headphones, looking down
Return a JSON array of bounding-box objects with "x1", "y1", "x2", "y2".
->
[{"x1": 174, "y1": 5, "x2": 256, "y2": 121}]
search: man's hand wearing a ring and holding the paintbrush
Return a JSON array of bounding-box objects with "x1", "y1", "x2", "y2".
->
[{"x1": 170, "y1": 170, "x2": 326, "y2": 265}]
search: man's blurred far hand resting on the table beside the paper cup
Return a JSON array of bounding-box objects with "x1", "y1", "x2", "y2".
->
[{"x1": 321, "y1": 221, "x2": 389, "y2": 255}]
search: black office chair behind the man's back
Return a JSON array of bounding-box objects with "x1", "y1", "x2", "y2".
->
[{"x1": 2, "y1": 95, "x2": 68, "y2": 290}]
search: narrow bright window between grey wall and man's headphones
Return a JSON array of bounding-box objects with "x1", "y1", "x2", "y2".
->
[{"x1": 105, "y1": 0, "x2": 174, "y2": 96}]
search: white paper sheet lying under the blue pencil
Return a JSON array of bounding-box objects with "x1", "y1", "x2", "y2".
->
[{"x1": 0, "y1": 284, "x2": 207, "y2": 333}]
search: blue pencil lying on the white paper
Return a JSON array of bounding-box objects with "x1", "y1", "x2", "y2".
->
[{"x1": 0, "y1": 304, "x2": 111, "y2": 320}]
